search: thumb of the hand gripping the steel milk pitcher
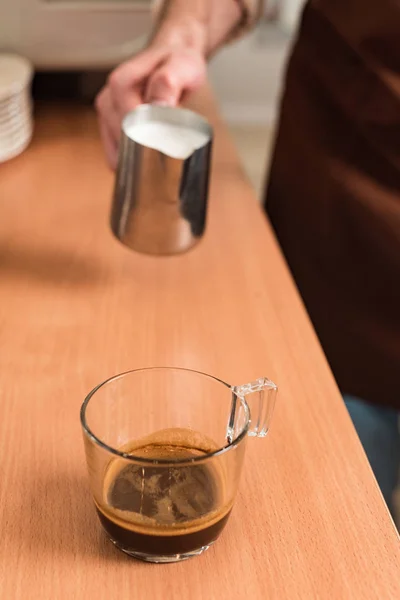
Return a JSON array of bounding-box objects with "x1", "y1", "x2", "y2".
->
[{"x1": 145, "y1": 55, "x2": 206, "y2": 106}]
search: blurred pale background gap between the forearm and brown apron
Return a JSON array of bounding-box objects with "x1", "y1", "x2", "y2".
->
[{"x1": 210, "y1": 0, "x2": 305, "y2": 198}]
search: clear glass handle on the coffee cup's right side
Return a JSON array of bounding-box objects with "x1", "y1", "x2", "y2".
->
[{"x1": 232, "y1": 377, "x2": 278, "y2": 437}]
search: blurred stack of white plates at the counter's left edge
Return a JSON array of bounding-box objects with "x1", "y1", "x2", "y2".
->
[{"x1": 0, "y1": 54, "x2": 33, "y2": 163}]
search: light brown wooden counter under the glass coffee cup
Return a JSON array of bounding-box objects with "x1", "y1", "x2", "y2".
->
[{"x1": 0, "y1": 92, "x2": 400, "y2": 600}]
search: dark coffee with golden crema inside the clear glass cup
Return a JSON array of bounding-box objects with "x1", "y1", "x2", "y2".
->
[{"x1": 96, "y1": 429, "x2": 232, "y2": 556}]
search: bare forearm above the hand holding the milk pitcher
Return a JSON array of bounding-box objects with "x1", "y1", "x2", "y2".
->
[{"x1": 152, "y1": 0, "x2": 243, "y2": 56}]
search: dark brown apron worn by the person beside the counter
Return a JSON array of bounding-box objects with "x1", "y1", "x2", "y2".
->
[{"x1": 267, "y1": 0, "x2": 400, "y2": 409}]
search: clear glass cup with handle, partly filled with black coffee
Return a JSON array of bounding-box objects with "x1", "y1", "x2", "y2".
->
[{"x1": 81, "y1": 368, "x2": 277, "y2": 563}]
